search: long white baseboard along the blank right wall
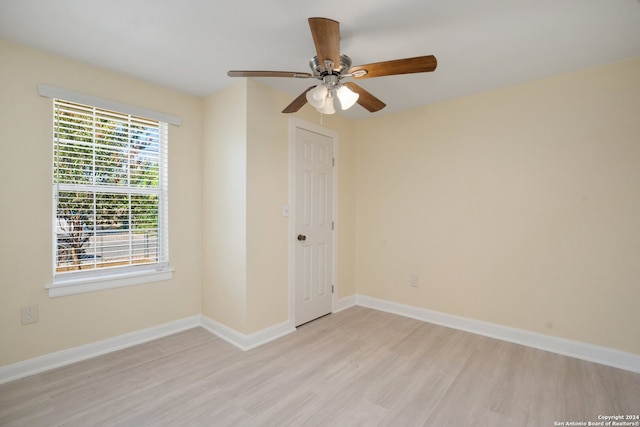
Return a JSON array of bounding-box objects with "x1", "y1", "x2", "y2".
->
[{"x1": 355, "y1": 295, "x2": 640, "y2": 373}]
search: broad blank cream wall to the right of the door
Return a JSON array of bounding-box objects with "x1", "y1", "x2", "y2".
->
[{"x1": 356, "y1": 59, "x2": 640, "y2": 354}]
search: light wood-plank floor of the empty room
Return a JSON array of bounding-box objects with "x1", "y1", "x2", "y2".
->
[{"x1": 0, "y1": 307, "x2": 640, "y2": 427}]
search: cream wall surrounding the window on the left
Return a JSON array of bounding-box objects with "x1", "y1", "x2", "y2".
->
[{"x1": 0, "y1": 40, "x2": 202, "y2": 365}]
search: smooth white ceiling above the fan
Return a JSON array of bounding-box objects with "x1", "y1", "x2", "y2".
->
[{"x1": 0, "y1": 0, "x2": 640, "y2": 119}]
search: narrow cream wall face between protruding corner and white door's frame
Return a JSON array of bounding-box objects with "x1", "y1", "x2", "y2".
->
[{"x1": 247, "y1": 79, "x2": 289, "y2": 332}]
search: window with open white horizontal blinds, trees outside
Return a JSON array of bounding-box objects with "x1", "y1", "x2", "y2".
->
[{"x1": 49, "y1": 99, "x2": 170, "y2": 296}]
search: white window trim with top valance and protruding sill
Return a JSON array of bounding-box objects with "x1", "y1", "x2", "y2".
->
[{"x1": 38, "y1": 85, "x2": 181, "y2": 297}]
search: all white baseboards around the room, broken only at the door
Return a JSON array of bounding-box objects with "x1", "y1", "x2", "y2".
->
[{"x1": 0, "y1": 295, "x2": 640, "y2": 384}]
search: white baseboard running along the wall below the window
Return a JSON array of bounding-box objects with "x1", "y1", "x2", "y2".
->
[{"x1": 0, "y1": 316, "x2": 200, "y2": 384}]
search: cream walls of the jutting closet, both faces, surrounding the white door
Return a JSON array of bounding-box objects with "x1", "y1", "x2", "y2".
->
[{"x1": 203, "y1": 79, "x2": 355, "y2": 334}]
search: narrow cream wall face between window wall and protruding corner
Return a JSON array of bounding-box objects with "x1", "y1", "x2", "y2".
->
[{"x1": 201, "y1": 79, "x2": 248, "y2": 334}]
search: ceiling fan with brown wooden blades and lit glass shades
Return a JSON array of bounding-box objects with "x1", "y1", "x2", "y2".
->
[{"x1": 227, "y1": 18, "x2": 438, "y2": 114}]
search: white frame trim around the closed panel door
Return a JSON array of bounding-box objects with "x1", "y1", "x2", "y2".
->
[{"x1": 288, "y1": 117, "x2": 338, "y2": 327}]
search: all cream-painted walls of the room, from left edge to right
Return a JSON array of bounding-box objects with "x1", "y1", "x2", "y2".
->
[{"x1": 0, "y1": 36, "x2": 640, "y2": 365}]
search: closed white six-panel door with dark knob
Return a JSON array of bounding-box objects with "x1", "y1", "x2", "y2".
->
[{"x1": 292, "y1": 127, "x2": 333, "y2": 326}]
